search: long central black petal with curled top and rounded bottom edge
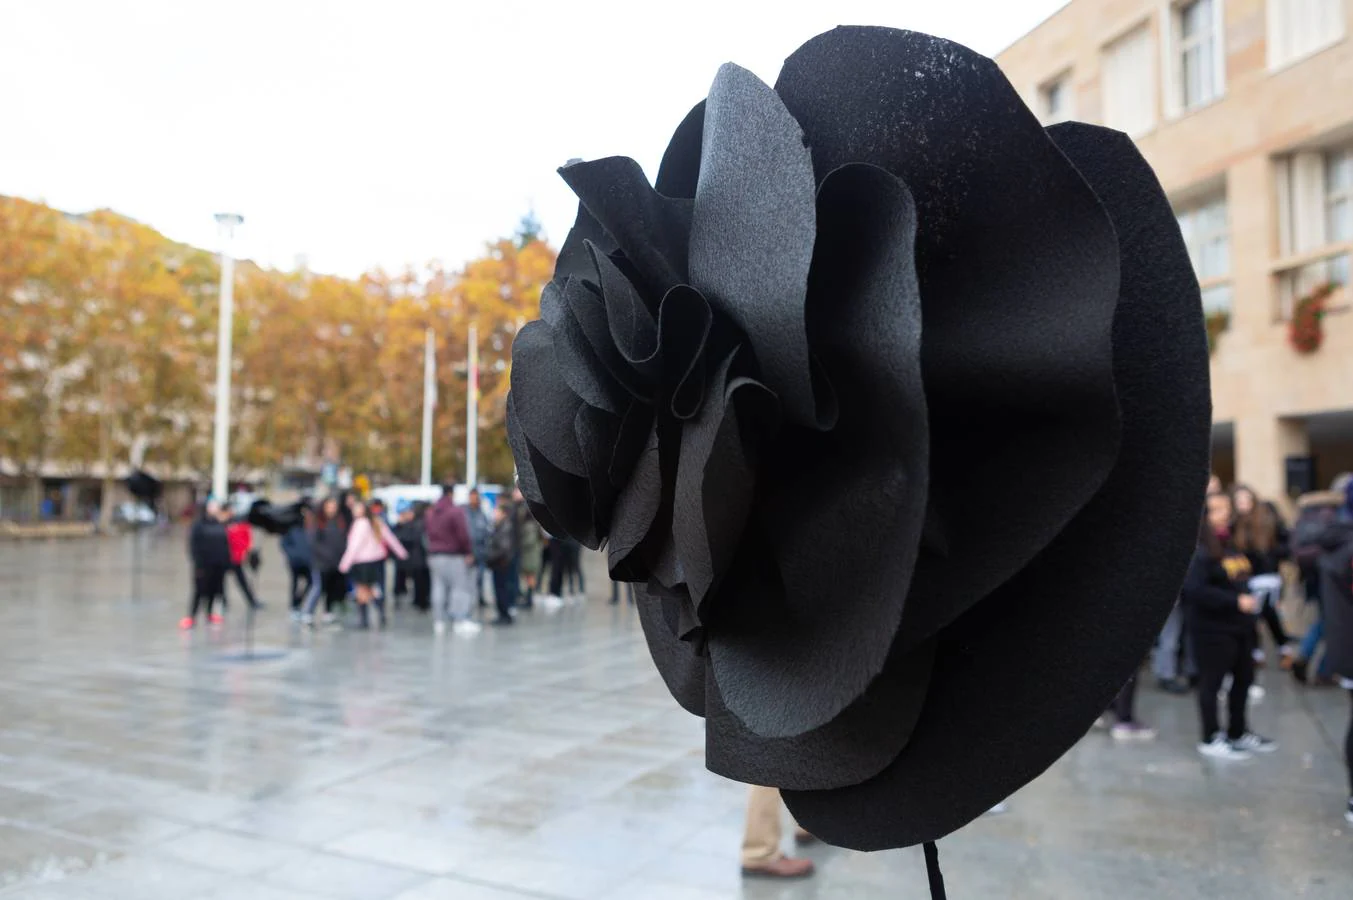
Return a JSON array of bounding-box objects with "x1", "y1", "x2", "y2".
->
[{"x1": 709, "y1": 165, "x2": 930, "y2": 736}]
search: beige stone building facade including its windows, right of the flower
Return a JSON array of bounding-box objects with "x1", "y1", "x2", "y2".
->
[{"x1": 997, "y1": 0, "x2": 1353, "y2": 498}]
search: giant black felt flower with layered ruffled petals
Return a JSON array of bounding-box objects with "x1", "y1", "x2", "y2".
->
[{"x1": 507, "y1": 22, "x2": 1210, "y2": 849}]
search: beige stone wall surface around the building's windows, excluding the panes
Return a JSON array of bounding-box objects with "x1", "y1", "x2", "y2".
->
[{"x1": 997, "y1": 0, "x2": 1353, "y2": 495}]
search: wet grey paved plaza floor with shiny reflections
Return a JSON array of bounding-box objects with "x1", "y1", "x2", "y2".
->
[{"x1": 0, "y1": 535, "x2": 1353, "y2": 900}]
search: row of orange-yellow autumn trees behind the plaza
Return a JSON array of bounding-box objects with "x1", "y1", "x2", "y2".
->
[{"x1": 0, "y1": 198, "x2": 555, "y2": 513}]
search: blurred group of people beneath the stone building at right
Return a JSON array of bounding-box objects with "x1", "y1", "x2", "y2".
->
[{"x1": 1099, "y1": 476, "x2": 1353, "y2": 823}]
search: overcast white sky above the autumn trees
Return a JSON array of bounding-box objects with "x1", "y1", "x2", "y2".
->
[{"x1": 0, "y1": 0, "x2": 1065, "y2": 275}]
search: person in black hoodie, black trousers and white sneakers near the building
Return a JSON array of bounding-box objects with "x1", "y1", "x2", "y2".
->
[{"x1": 1183, "y1": 494, "x2": 1277, "y2": 759}]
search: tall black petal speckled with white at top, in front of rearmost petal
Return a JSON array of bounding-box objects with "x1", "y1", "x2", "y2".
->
[{"x1": 775, "y1": 28, "x2": 1119, "y2": 642}]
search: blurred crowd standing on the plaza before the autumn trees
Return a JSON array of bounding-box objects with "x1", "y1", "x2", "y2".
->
[{"x1": 179, "y1": 485, "x2": 592, "y2": 636}]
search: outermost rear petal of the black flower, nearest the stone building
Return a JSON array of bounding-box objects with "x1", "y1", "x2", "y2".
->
[{"x1": 785, "y1": 125, "x2": 1211, "y2": 850}]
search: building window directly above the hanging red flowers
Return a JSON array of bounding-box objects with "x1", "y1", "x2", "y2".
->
[{"x1": 1277, "y1": 143, "x2": 1353, "y2": 318}]
